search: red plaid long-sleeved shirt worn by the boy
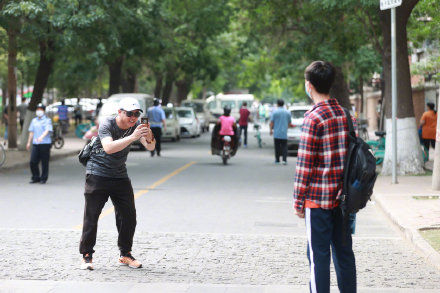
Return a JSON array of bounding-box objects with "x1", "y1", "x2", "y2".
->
[{"x1": 293, "y1": 99, "x2": 354, "y2": 212}]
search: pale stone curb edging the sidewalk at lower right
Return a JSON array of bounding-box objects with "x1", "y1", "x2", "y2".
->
[{"x1": 373, "y1": 194, "x2": 440, "y2": 270}]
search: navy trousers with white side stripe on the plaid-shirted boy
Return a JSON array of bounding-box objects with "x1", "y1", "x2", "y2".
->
[{"x1": 305, "y1": 208, "x2": 356, "y2": 293}]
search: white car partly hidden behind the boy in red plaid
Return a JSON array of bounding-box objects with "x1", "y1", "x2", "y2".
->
[{"x1": 287, "y1": 105, "x2": 313, "y2": 155}]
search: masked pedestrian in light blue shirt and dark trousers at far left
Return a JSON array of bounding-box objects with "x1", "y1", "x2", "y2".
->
[{"x1": 26, "y1": 104, "x2": 53, "y2": 184}]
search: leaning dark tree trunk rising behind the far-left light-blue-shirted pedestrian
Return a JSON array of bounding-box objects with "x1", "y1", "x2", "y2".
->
[{"x1": 18, "y1": 40, "x2": 55, "y2": 150}]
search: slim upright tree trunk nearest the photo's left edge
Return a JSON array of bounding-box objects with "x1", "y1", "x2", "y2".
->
[{"x1": 7, "y1": 24, "x2": 17, "y2": 148}]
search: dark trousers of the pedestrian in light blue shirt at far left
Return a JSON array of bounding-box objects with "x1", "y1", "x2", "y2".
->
[{"x1": 30, "y1": 143, "x2": 51, "y2": 181}]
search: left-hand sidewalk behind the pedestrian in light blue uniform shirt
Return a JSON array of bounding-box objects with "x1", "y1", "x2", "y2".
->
[{"x1": 0, "y1": 137, "x2": 85, "y2": 172}]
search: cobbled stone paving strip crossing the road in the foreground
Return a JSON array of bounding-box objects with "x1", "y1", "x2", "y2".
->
[{"x1": 0, "y1": 230, "x2": 440, "y2": 290}]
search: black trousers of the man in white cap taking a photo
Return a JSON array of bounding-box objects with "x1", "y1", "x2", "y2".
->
[{"x1": 79, "y1": 174, "x2": 136, "y2": 255}]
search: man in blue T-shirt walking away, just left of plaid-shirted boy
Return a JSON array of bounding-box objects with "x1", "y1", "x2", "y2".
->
[{"x1": 269, "y1": 99, "x2": 292, "y2": 165}]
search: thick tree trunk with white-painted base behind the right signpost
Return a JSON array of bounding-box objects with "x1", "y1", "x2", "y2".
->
[{"x1": 380, "y1": 0, "x2": 424, "y2": 175}]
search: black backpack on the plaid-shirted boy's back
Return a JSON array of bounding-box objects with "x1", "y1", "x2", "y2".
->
[{"x1": 341, "y1": 108, "x2": 377, "y2": 216}]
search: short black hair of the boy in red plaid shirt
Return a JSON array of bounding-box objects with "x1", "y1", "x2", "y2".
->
[{"x1": 304, "y1": 61, "x2": 335, "y2": 94}]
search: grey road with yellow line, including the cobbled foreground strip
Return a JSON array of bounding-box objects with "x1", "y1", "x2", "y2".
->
[{"x1": 0, "y1": 126, "x2": 440, "y2": 291}]
